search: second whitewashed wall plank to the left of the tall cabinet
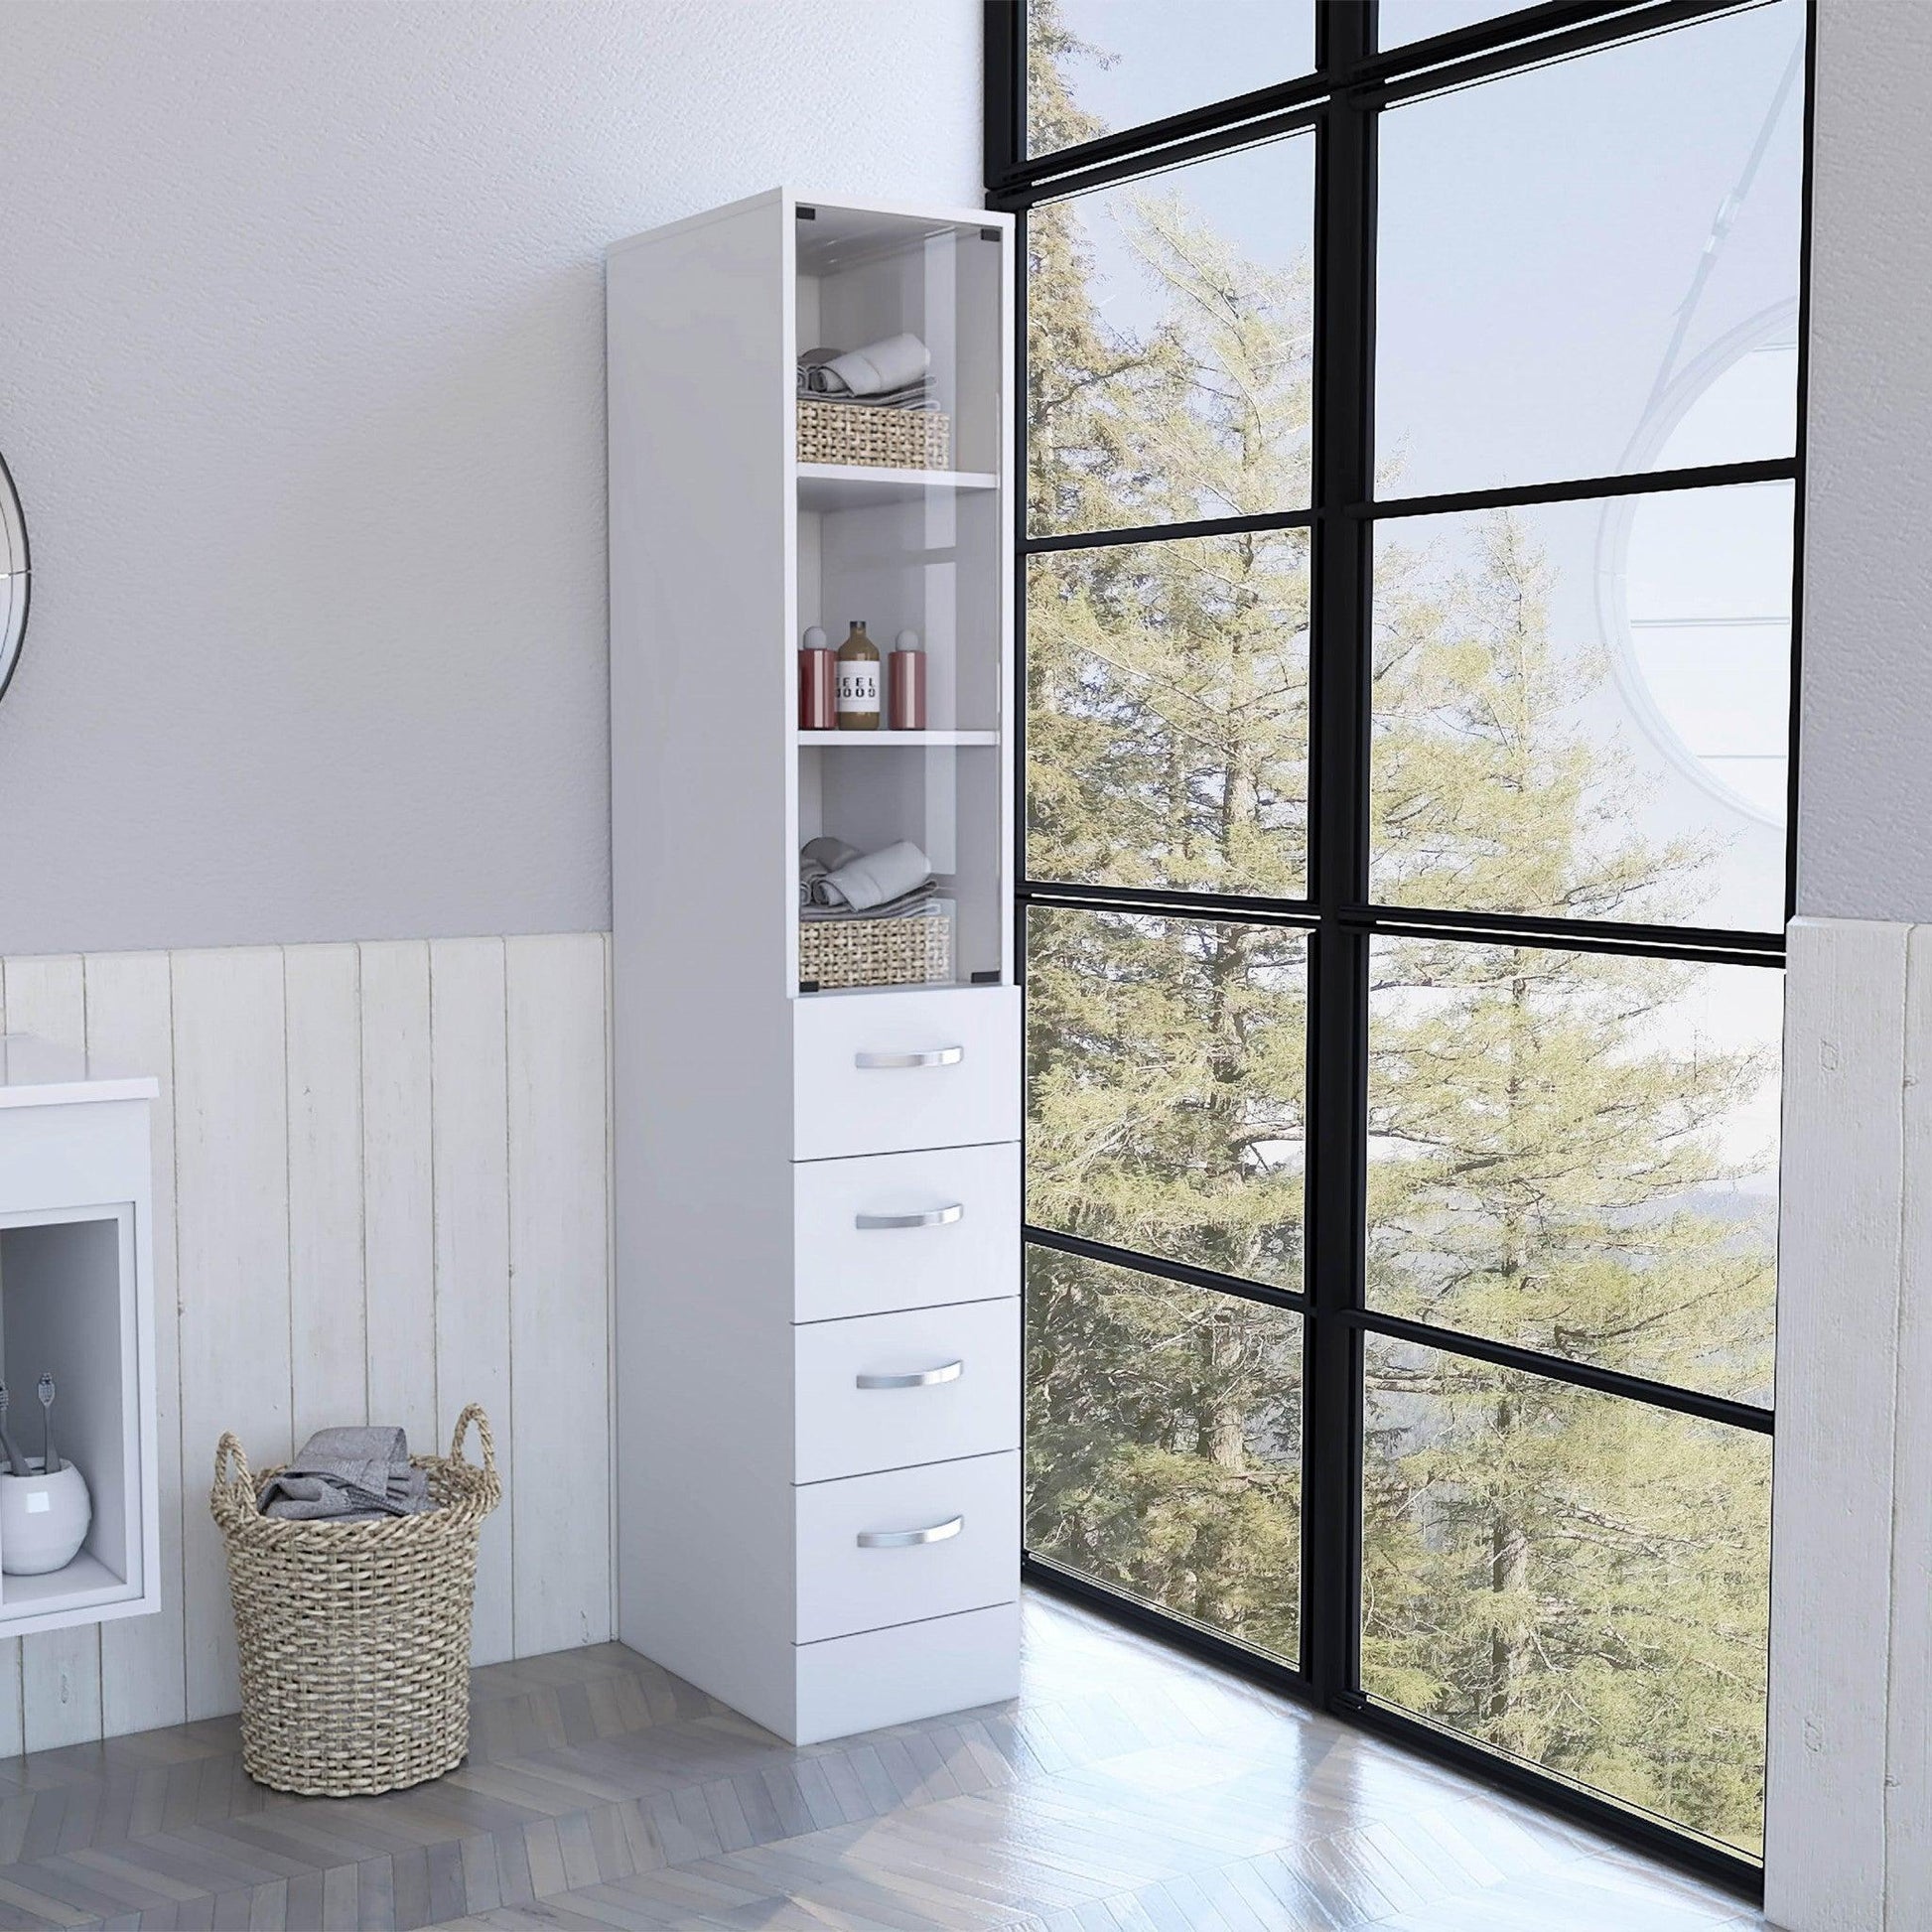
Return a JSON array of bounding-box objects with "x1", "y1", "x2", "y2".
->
[{"x1": 429, "y1": 939, "x2": 514, "y2": 1664}]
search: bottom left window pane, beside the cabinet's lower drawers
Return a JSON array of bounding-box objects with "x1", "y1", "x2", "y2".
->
[{"x1": 1026, "y1": 1248, "x2": 1303, "y2": 1664}]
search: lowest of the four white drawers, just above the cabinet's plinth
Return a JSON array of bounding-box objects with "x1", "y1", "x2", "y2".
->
[{"x1": 794, "y1": 1450, "x2": 1020, "y2": 1644}]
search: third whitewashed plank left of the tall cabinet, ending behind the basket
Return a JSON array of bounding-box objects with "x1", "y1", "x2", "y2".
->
[{"x1": 361, "y1": 939, "x2": 437, "y2": 1449}]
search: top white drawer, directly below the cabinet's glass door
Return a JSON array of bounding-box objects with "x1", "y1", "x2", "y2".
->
[{"x1": 792, "y1": 985, "x2": 1020, "y2": 1162}]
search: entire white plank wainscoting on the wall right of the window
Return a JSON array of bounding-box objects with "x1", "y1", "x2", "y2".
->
[{"x1": 1764, "y1": 919, "x2": 1932, "y2": 1932}]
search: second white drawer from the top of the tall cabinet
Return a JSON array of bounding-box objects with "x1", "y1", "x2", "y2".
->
[{"x1": 792, "y1": 1142, "x2": 1020, "y2": 1321}]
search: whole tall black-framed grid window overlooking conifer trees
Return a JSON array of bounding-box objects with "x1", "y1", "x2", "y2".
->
[{"x1": 987, "y1": 0, "x2": 1810, "y2": 1889}]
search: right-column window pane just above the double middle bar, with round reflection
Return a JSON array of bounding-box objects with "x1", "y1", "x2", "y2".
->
[{"x1": 1370, "y1": 483, "x2": 1793, "y2": 931}]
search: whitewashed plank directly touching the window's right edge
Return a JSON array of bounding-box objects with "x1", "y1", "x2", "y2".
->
[{"x1": 1764, "y1": 919, "x2": 1922, "y2": 1932}]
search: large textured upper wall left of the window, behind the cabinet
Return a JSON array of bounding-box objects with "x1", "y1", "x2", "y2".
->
[{"x1": 0, "y1": 0, "x2": 980, "y2": 952}]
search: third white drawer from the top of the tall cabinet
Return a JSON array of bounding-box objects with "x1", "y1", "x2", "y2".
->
[{"x1": 792, "y1": 1299, "x2": 1020, "y2": 1482}]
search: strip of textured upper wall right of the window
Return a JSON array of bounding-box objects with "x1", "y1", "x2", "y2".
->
[{"x1": 1799, "y1": 0, "x2": 1932, "y2": 919}]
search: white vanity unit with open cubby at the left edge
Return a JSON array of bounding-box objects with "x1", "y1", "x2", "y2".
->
[{"x1": 0, "y1": 1034, "x2": 161, "y2": 1636}]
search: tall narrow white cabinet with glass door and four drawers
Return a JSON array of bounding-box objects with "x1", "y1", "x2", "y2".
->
[{"x1": 609, "y1": 190, "x2": 1020, "y2": 1742}]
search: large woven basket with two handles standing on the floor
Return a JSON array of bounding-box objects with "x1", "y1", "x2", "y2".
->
[{"x1": 208, "y1": 1403, "x2": 502, "y2": 1799}]
